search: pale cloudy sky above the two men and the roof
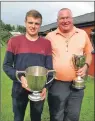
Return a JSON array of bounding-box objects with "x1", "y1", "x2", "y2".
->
[{"x1": 1, "y1": 1, "x2": 94, "y2": 26}]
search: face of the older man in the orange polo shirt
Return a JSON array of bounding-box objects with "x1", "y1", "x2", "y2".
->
[{"x1": 57, "y1": 10, "x2": 73, "y2": 32}]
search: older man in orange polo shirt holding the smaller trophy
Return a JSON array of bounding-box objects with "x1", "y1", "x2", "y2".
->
[{"x1": 46, "y1": 8, "x2": 93, "y2": 121}]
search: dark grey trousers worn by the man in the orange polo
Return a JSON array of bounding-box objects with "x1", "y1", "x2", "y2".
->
[{"x1": 48, "y1": 80, "x2": 84, "y2": 121}]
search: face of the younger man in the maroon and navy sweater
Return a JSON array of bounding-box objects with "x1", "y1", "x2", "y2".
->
[{"x1": 25, "y1": 17, "x2": 41, "y2": 36}]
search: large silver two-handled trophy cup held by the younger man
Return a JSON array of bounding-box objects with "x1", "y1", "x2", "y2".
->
[{"x1": 16, "y1": 66, "x2": 55, "y2": 101}]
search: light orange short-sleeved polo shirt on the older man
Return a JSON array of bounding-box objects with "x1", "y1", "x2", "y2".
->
[{"x1": 46, "y1": 26, "x2": 93, "y2": 81}]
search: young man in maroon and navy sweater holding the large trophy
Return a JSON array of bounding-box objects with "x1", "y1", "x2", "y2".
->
[{"x1": 3, "y1": 10, "x2": 52, "y2": 121}]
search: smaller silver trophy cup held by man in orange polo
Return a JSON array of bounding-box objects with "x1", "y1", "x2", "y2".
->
[{"x1": 72, "y1": 54, "x2": 85, "y2": 89}]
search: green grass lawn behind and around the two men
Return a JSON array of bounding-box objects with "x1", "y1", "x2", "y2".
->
[{"x1": 0, "y1": 47, "x2": 94, "y2": 121}]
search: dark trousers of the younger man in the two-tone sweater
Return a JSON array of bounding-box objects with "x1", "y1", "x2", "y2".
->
[{"x1": 12, "y1": 97, "x2": 44, "y2": 121}]
